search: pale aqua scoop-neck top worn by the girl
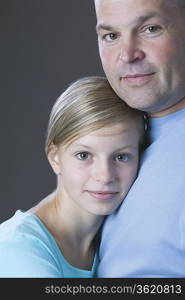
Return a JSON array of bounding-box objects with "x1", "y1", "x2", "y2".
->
[{"x1": 0, "y1": 210, "x2": 98, "y2": 278}]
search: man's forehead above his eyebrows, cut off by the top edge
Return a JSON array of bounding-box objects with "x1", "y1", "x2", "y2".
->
[{"x1": 94, "y1": 0, "x2": 185, "y2": 32}]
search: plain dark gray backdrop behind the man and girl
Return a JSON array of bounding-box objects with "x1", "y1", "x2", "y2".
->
[{"x1": 0, "y1": 0, "x2": 103, "y2": 222}]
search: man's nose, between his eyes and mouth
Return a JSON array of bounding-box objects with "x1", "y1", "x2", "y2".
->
[{"x1": 119, "y1": 37, "x2": 145, "y2": 64}]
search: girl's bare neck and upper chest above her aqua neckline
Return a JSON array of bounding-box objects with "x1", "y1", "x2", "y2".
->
[{"x1": 30, "y1": 193, "x2": 103, "y2": 270}]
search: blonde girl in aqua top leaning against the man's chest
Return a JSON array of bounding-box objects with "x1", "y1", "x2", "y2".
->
[{"x1": 0, "y1": 76, "x2": 144, "y2": 278}]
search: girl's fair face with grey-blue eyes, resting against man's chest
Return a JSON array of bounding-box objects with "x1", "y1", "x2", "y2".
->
[{"x1": 48, "y1": 121, "x2": 139, "y2": 216}]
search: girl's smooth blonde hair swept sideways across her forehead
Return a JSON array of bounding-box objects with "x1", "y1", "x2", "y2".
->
[{"x1": 45, "y1": 76, "x2": 144, "y2": 153}]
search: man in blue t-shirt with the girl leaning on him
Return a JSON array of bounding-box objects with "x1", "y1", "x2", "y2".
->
[{"x1": 95, "y1": 0, "x2": 185, "y2": 277}]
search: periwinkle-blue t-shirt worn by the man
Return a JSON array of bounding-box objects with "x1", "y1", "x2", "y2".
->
[{"x1": 98, "y1": 109, "x2": 185, "y2": 278}]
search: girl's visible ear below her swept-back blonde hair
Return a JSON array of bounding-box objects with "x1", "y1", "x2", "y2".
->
[{"x1": 47, "y1": 143, "x2": 60, "y2": 175}]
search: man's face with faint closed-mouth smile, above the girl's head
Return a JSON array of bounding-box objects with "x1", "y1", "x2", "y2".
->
[{"x1": 95, "y1": 0, "x2": 185, "y2": 116}]
